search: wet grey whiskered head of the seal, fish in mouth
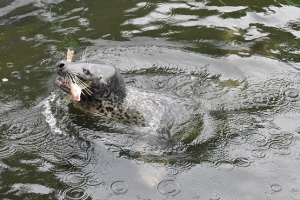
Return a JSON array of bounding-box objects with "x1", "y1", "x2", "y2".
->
[{"x1": 56, "y1": 61, "x2": 126, "y2": 102}]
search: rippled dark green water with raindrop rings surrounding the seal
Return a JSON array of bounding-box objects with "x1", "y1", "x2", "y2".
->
[{"x1": 0, "y1": 0, "x2": 300, "y2": 200}]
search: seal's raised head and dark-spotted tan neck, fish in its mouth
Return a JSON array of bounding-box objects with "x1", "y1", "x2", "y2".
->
[{"x1": 56, "y1": 61, "x2": 144, "y2": 124}]
